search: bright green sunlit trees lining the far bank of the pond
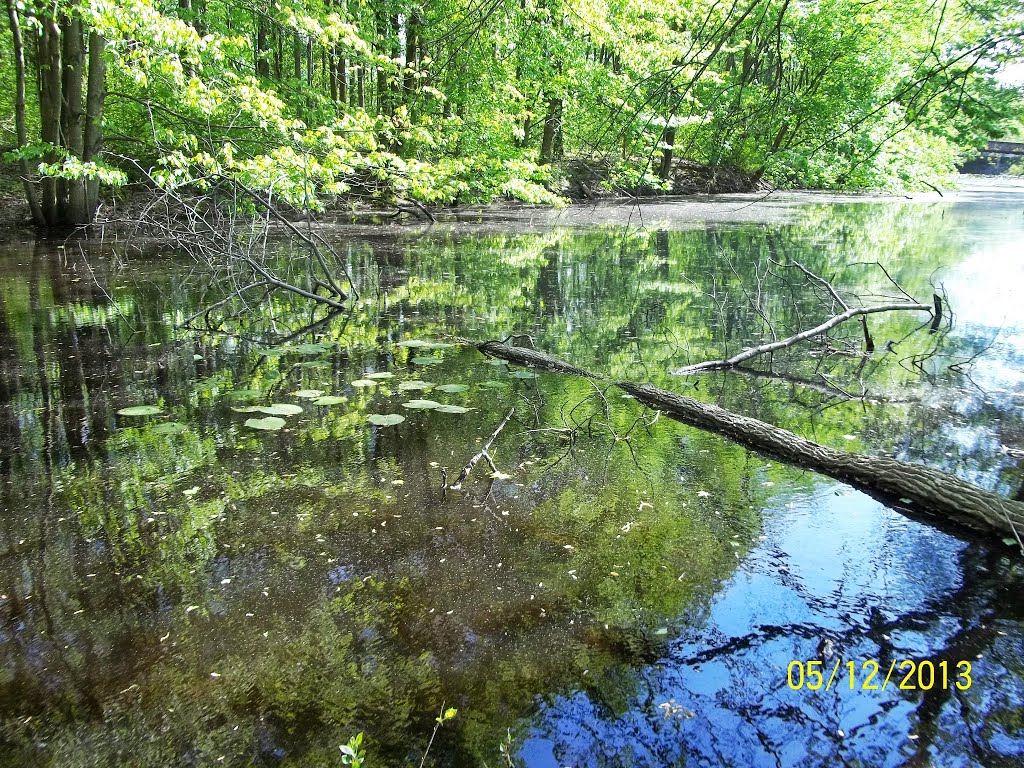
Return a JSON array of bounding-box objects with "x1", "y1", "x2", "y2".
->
[{"x1": 0, "y1": 0, "x2": 1024, "y2": 225}]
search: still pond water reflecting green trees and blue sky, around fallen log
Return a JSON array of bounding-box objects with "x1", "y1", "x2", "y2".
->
[{"x1": 0, "y1": 190, "x2": 1024, "y2": 767}]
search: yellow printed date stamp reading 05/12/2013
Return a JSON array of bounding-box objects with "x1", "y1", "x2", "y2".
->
[{"x1": 785, "y1": 658, "x2": 973, "y2": 690}]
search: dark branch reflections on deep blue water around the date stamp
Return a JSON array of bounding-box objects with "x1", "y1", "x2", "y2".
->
[{"x1": 522, "y1": 543, "x2": 1024, "y2": 766}]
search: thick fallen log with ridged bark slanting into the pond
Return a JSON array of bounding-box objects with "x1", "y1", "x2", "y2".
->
[{"x1": 478, "y1": 342, "x2": 1024, "y2": 538}]
